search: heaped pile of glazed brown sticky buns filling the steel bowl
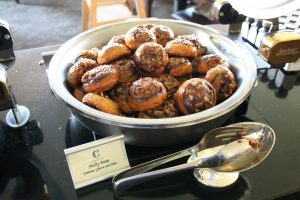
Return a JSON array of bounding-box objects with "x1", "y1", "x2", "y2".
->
[{"x1": 67, "y1": 24, "x2": 237, "y2": 119}]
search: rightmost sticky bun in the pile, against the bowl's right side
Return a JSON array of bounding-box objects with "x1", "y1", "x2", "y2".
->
[{"x1": 205, "y1": 65, "x2": 237, "y2": 102}]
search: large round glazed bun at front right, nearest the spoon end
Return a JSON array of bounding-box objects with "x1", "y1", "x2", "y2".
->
[{"x1": 174, "y1": 78, "x2": 217, "y2": 115}]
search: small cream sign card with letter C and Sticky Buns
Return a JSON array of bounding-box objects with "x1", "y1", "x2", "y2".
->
[{"x1": 64, "y1": 135, "x2": 130, "y2": 189}]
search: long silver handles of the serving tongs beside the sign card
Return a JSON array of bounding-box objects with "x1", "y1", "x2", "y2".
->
[{"x1": 112, "y1": 148, "x2": 192, "y2": 196}]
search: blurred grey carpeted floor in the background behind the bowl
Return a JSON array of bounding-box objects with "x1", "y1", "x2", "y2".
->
[{"x1": 0, "y1": 0, "x2": 173, "y2": 50}]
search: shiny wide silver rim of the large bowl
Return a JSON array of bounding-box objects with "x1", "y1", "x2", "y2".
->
[{"x1": 47, "y1": 19, "x2": 257, "y2": 128}]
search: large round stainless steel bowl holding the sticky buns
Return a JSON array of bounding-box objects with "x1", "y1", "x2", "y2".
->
[{"x1": 48, "y1": 19, "x2": 256, "y2": 146}]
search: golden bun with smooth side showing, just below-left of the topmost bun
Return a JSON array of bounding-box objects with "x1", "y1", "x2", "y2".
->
[{"x1": 97, "y1": 43, "x2": 130, "y2": 64}]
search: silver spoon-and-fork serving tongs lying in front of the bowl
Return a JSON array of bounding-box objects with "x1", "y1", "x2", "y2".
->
[{"x1": 112, "y1": 122, "x2": 275, "y2": 196}]
